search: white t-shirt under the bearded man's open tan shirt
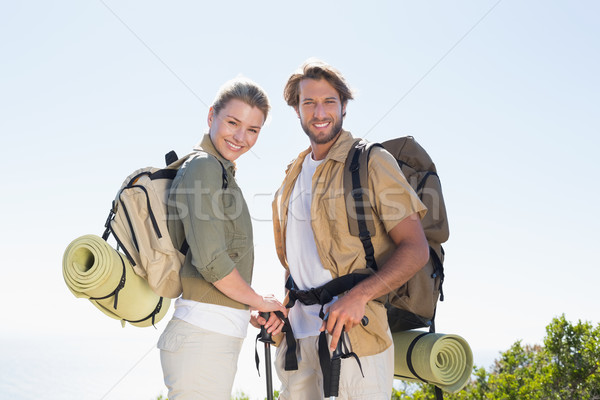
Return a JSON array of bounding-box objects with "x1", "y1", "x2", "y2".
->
[{"x1": 286, "y1": 153, "x2": 332, "y2": 339}]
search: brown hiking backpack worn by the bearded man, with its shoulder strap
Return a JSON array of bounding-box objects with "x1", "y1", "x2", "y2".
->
[{"x1": 344, "y1": 136, "x2": 449, "y2": 332}]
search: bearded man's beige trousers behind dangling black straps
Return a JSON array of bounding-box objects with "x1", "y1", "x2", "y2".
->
[{"x1": 275, "y1": 336, "x2": 394, "y2": 400}]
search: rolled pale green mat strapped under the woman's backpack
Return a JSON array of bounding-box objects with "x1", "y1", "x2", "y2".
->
[{"x1": 63, "y1": 235, "x2": 171, "y2": 327}]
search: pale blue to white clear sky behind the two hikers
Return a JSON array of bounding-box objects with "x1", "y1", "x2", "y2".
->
[{"x1": 0, "y1": 0, "x2": 600, "y2": 399}]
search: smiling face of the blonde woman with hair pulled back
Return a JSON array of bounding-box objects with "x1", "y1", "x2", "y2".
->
[{"x1": 208, "y1": 99, "x2": 265, "y2": 161}]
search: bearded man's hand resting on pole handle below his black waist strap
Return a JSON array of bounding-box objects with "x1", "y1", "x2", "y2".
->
[{"x1": 320, "y1": 291, "x2": 368, "y2": 351}]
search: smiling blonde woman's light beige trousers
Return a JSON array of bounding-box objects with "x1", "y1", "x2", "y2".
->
[{"x1": 158, "y1": 318, "x2": 244, "y2": 400}]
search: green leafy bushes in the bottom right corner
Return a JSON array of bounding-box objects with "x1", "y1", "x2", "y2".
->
[{"x1": 392, "y1": 315, "x2": 600, "y2": 400}]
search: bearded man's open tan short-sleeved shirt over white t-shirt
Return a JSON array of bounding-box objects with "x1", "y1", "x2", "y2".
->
[{"x1": 273, "y1": 131, "x2": 427, "y2": 357}]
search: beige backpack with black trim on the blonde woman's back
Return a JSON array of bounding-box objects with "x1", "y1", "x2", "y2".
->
[{"x1": 102, "y1": 151, "x2": 194, "y2": 298}]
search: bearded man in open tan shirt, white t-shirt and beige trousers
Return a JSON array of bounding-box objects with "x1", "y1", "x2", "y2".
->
[{"x1": 273, "y1": 59, "x2": 429, "y2": 400}]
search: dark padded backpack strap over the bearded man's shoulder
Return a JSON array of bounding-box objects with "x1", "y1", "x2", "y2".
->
[{"x1": 343, "y1": 139, "x2": 382, "y2": 270}]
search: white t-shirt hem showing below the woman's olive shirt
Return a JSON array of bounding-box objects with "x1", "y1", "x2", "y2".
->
[{"x1": 173, "y1": 297, "x2": 250, "y2": 339}]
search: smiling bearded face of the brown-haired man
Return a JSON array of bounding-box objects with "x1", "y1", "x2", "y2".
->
[{"x1": 296, "y1": 79, "x2": 346, "y2": 144}]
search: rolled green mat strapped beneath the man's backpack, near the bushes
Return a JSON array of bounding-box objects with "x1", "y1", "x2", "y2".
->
[{"x1": 392, "y1": 330, "x2": 473, "y2": 393}]
